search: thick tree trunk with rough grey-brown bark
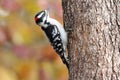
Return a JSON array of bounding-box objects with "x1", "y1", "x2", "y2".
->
[{"x1": 62, "y1": 0, "x2": 120, "y2": 80}]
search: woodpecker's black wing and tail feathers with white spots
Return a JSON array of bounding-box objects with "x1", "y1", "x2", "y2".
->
[{"x1": 42, "y1": 25, "x2": 68, "y2": 66}]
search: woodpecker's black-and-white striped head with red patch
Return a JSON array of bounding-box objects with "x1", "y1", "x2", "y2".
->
[{"x1": 35, "y1": 10, "x2": 49, "y2": 26}]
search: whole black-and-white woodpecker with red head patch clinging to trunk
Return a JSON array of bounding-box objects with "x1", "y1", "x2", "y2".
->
[{"x1": 35, "y1": 10, "x2": 69, "y2": 68}]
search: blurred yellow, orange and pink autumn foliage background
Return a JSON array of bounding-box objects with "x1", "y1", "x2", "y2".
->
[{"x1": 0, "y1": 0, "x2": 68, "y2": 80}]
